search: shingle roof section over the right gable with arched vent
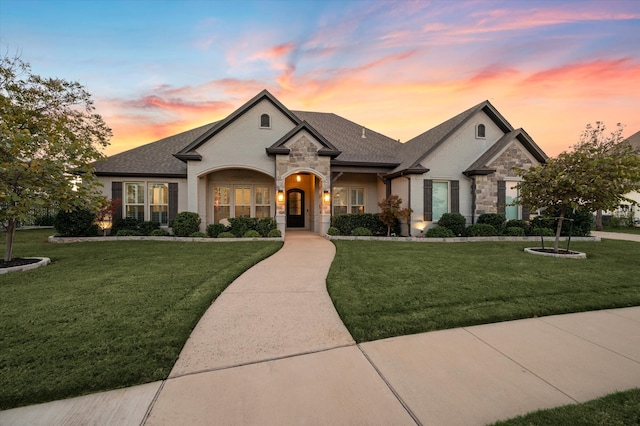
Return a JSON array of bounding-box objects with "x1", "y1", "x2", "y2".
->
[{"x1": 392, "y1": 101, "x2": 513, "y2": 173}]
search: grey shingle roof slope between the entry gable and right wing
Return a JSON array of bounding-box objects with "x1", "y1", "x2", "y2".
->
[{"x1": 292, "y1": 111, "x2": 402, "y2": 167}]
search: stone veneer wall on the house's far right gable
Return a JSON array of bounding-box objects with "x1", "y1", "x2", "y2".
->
[{"x1": 475, "y1": 143, "x2": 533, "y2": 218}]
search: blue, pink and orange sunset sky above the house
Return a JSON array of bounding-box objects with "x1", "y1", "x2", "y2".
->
[{"x1": 0, "y1": 0, "x2": 640, "y2": 156}]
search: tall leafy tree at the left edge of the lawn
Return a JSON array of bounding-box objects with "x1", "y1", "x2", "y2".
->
[{"x1": 0, "y1": 54, "x2": 111, "y2": 261}]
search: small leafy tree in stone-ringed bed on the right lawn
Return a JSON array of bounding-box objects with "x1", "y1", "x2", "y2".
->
[{"x1": 517, "y1": 122, "x2": 640, "y2": 251}]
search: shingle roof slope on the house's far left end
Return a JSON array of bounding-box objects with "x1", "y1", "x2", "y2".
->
[{"x1": 95, "y1": 122, "x2": 217, "y2": 177}]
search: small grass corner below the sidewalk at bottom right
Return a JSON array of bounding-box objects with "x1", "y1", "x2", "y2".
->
[{"x1": 494, "y1": 389, "x2": 640, "y2": 426}]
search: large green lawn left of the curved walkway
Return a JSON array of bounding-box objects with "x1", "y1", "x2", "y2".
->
[{"x1": 0, "y1": 230, "x2": 282, "y2": 409}]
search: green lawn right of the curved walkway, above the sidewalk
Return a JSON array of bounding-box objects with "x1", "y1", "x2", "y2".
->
[{"x1": 327, "y1": 240, "x2": 640, "y2": 342}]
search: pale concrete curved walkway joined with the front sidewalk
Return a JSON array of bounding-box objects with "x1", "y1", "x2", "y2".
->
[{"x1": 0, "y1": 232, "x2": 640, "y2": 426}]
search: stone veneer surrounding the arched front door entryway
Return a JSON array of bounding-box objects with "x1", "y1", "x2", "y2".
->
[{"x1": 276, "y1": 136, "x2": 331, "y2": 215}]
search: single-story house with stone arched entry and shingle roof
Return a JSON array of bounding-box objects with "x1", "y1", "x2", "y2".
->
[{"x1": 96, "y1": 90, "x2": 547, "y2": 235}]
